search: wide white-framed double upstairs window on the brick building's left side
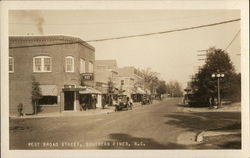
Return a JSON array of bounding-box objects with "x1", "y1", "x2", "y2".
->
[{"x1": 33, "y1": 56, "x2": 52, "y2": 72}]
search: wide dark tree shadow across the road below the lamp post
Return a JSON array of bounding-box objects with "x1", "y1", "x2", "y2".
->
[{"x1": 164, "y1": 112, "x2": 241, "y2": 131}]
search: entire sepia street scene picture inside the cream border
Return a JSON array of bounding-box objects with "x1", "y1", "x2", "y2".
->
[{"x1": 8, "y1": 9, "x2": 242, "y2": 150}]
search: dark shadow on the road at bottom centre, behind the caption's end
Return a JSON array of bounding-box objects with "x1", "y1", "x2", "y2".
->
[{"x1": 99, "y1": 133, "x2": 186, "y2": 149}]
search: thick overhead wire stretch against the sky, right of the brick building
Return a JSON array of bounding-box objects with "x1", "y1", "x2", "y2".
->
[{"x1": 86, "y1": 18, "x2": 240, "y2": 42}]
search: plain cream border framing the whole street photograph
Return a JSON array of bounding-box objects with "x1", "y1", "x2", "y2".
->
[{"x1": 1, "y1": 0, "x2": 250, "y2": 158}]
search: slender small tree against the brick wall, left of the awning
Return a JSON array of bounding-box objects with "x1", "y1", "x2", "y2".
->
[{"x1": 31, "y1": 76, "x2": 42, "y2": 114}]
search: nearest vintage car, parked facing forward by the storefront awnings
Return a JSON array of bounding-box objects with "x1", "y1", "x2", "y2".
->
[{"x1": 115, "y1": 95, "x2": 133, "y2": 111}]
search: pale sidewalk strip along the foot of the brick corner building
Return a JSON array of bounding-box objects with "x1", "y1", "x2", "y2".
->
[{"x1": 10, "y1": 106, "x2": 115, "y2": 119}]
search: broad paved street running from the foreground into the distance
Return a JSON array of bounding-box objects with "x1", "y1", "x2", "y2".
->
[{"x1": 10, "y1": 98, "x2": 240, "y2": 149}]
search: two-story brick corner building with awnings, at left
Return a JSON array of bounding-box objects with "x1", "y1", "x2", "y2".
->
[{"x1": 9, "y1": 36, "x2": 99, "y2": 115}]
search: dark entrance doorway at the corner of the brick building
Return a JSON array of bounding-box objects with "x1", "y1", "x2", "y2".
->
[{"x1": 64, "y1": 91, "x2": 75, "y2": 110}]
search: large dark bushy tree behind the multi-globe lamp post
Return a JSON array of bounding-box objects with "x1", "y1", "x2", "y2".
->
[{"x1": 191, "y1": 47, "x2": 240, "y2": 105}]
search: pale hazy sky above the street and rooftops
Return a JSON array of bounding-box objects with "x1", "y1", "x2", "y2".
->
[{"x1": 9, "y1": 10, "x2": 241, "y2": 88}]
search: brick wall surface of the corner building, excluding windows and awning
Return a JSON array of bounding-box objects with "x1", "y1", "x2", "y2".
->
[{"x1": 9, "y1": 36, "x2": 95, "y2": 115}]
